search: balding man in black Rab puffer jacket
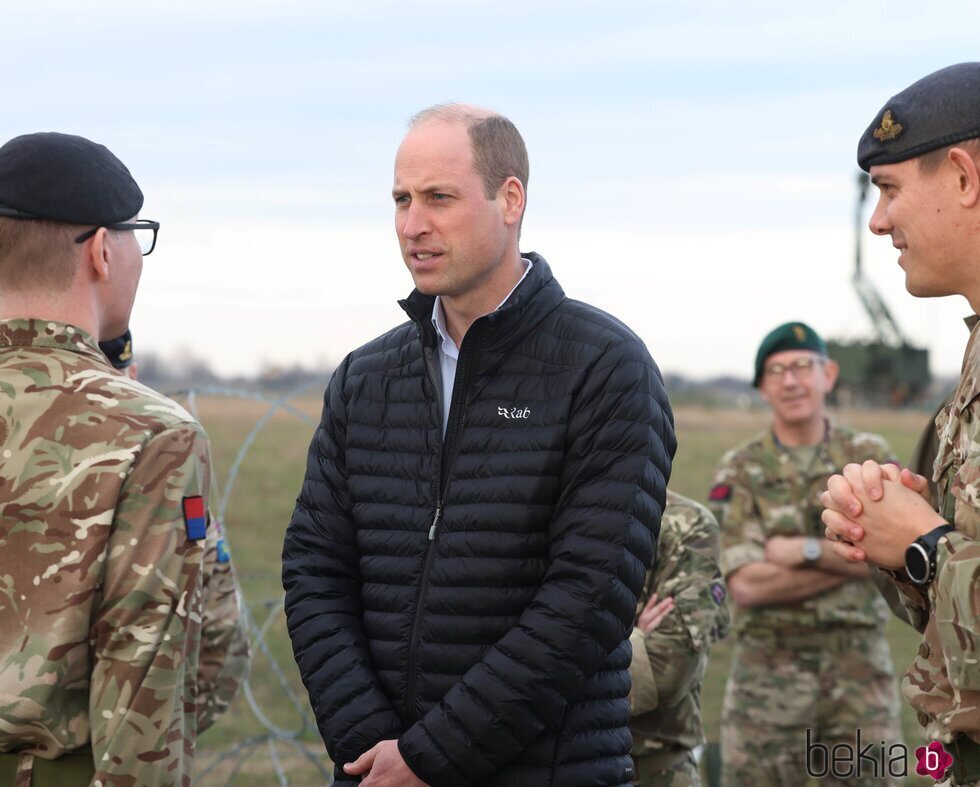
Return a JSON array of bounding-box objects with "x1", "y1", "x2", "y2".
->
[{"x1": 283, "y1": 104, "x2": 675, "y2": 787}]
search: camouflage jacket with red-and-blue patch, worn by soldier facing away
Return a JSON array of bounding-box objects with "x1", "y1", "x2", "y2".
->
[{"x1": 0, "y1": 320, "x2": 248, "y2": 787}]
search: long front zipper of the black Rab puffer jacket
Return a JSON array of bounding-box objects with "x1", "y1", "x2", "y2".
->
[{"x1": 405, "y1": 320, "x2": 482, "y2": 724}]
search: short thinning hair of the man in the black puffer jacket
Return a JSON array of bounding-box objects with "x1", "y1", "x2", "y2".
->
[{"x1": 408, "y1": 104, "x2": 529, "y2": 199}]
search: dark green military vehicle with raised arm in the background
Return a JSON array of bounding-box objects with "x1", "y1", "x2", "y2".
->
[{"x1": 827, "y1": 172, "x2": 931, "y2": 407}]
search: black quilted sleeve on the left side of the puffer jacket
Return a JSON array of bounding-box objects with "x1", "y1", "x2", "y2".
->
[{"x1": 282, "y1": 361, "x2": 403, "y2": 783}]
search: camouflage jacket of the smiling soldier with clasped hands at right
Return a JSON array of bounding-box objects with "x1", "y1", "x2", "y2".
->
[{"x1": 896, "y1": 323, "x2": 980, "y2": 743}]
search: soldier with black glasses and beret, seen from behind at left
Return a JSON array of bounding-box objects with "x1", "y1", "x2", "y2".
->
[{"x1": 0, "y1": 134, "x2": 248, "y2": 787}]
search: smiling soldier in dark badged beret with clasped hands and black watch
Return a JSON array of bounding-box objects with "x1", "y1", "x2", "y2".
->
[{"x1": 823, "y1": 63, "x2": 980, "y2": 786}]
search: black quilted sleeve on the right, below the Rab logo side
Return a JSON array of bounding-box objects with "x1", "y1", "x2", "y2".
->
[{"x1": 399, "y1": 338, "x2": 676, "y2": 785}]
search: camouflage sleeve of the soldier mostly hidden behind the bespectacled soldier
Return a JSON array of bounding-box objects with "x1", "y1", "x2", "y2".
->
[{"x1": 197, "y1": 519, "x2": 249, "y2": 732}]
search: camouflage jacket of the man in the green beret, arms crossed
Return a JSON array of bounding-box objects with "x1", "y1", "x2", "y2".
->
[{"x1": 709, "y1": 426, "x2": 894, "y2": 635}]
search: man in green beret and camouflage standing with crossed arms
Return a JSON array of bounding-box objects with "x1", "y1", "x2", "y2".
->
[{"x1": 709, "y1": 323, "x2": 901, "y2": 787}]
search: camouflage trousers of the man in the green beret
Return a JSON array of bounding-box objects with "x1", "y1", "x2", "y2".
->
[{"x1": 721, "y1": 629, "x2": 902, "y2": 787}]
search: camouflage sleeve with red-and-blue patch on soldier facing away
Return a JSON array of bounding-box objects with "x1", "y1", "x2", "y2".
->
[{"x1": 89, "y1": 424, "x2": 210, "y2": 787}]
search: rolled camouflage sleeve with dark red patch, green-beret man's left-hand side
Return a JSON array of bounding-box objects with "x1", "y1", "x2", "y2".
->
[{"x1": 708, "y1": 453, "x2": 766, "y2": 578}]
